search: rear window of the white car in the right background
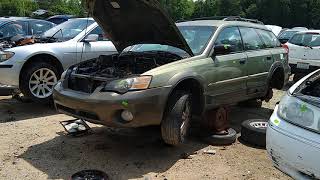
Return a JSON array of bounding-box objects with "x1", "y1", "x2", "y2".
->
[{"x1": 289, "y1": 33, "x2": 320, "y2": 47}]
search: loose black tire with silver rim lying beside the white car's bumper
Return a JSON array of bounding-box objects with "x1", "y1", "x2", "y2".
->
[{"x1": 240, "y1": 119, "x2": 268, "y2": 147}]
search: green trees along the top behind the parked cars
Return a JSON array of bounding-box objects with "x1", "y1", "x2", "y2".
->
[{"x1": 0, "y1": 0, "x2": 320, "y2": 28}]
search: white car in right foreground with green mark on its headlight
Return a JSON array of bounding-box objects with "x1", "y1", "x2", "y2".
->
[{"x1": 266, "y1": 70, "x2": 320, "y2": 179}]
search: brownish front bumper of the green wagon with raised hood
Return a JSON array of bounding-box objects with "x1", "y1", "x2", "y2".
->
[{"x1": 53, "y1": 82, "x2": 171, "y2": 127}]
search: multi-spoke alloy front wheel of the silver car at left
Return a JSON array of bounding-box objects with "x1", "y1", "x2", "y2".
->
[{"x1": 20, "y1": 61, "x2": 61, "y2": 104}]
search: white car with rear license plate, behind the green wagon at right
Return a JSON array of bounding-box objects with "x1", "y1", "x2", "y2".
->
[{"x1": 286, "y1": 30, "x2": 320, "y2": 81}]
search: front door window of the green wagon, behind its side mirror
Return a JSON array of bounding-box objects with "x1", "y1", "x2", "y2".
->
[{"x1": 215, "y1": 27, "x2": 243, "y2": 52}]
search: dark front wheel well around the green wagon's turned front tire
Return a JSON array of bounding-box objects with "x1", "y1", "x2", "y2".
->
[{"x1": 167, "y1": 78, "x2": 204, "y2": 115}]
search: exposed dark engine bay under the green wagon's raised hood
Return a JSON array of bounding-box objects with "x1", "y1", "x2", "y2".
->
[{"x1": 75, "y1": 51, "x2": 182, "y2": 78}]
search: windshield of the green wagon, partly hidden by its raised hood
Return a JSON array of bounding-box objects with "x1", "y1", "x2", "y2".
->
[{"x1": 124, "y1": 26, "x2": 217, "y2": 56}]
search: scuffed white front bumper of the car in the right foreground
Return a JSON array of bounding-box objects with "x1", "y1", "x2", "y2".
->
[{"x1": 267, "y1": 107, "x2": 320, "y2": 179}]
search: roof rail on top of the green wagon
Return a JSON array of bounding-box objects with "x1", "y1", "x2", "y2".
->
[{"x1": 177, "y1": 16, "x2": 264, "y2": 25}]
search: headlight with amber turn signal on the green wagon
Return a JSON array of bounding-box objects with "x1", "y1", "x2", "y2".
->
[{"x1": 104, "y1": 76, "x2": 152, "y2": 94}]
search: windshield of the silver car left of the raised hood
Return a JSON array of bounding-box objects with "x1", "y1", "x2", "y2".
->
[{"x1": 41, "y1": 19, "x2": 94, "y2": 41}]
